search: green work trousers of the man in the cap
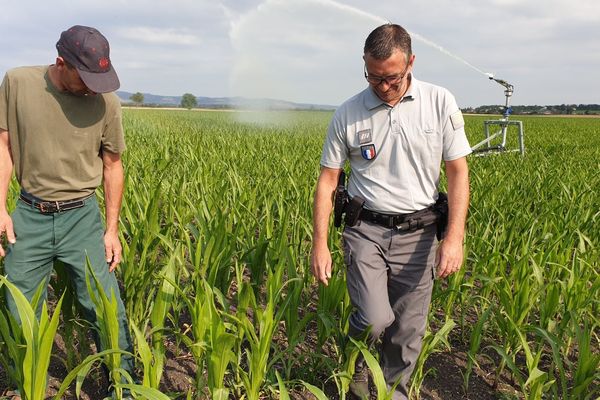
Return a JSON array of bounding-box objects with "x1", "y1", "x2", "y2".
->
[{"x1": 4, "y1": 196, "x2": 133, "y2": 376}]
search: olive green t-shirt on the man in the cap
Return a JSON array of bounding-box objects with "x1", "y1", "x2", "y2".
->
[{"x1": 0, "y1": 66, "x2": 125, "y2": 201}]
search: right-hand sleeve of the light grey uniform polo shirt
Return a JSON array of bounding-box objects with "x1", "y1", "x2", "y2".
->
[{"x1": 442, "y1": 93, "x2": 472, "y2": 161}]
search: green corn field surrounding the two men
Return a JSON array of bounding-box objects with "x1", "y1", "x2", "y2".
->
[{"x1": 0, "y1": 109, "x2": 600, "y2": 400}]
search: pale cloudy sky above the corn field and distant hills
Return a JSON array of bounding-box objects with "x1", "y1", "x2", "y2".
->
[{"x1": 0, "y1": 0, "x2": 600, "y2": 107}]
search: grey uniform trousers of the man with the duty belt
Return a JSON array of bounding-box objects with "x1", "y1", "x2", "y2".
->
[{"x1": 343, "y1": 221, "x2": 438, "y2": 399}]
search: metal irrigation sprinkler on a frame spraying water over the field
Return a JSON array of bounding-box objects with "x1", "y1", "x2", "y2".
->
[{"x1": 471, "y1": 73, "x2": 525, "y2": 155}]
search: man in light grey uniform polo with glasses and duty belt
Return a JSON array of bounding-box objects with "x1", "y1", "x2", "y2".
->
[{"x1": 311, "y1": 24, "x2": 471, "y2": 399}]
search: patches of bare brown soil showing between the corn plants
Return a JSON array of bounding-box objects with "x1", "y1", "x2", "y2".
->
[{"x1": 0, "y1": 285, "x2": 522, "y2": 400}]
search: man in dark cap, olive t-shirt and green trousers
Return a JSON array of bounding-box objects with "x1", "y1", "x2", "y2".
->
[{"x1": 0, "y1": 25, "x2": 133, "y2": 399}]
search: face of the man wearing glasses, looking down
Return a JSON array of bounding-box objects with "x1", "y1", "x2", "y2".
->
[{"x1": 363, "y1": 50, "x2": 415, "y2": 105}]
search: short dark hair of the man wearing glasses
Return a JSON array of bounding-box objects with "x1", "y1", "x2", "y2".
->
[{"x1": 364, "y1": 24, "x2": 412, "y2": 61}]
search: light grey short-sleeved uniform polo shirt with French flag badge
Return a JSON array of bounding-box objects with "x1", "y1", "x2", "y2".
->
[{"x1": 321, "y1": 76, "x2": 471, "y2": 214}]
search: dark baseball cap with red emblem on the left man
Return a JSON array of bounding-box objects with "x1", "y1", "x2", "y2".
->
[{"x1": 56, "y1": 25, "x2": 121, "y2": 93}]
